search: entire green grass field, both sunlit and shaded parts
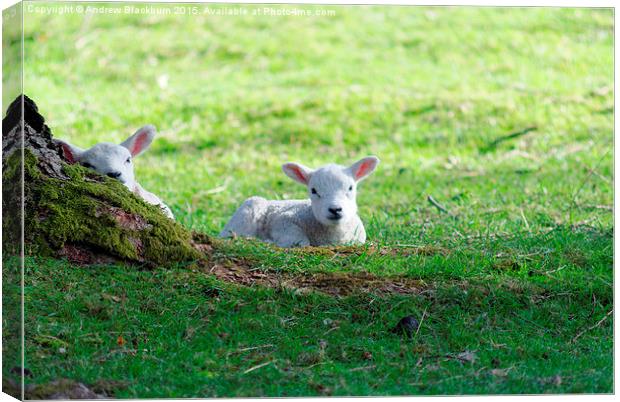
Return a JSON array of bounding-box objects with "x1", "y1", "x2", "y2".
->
[{"x1": 4, "y1": 5, "x2": 614, "y2": 398}]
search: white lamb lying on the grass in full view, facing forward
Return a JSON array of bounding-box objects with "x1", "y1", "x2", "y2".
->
[{"x1": 219, "y1": 156, "x2": 379, "y2": 247}]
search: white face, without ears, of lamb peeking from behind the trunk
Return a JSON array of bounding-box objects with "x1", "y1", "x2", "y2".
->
[{"x1": 77, "y1": 142, "x2": 135, "y2": 189}]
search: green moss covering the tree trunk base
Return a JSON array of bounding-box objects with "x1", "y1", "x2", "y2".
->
[{"x1": 3, "y1": 150, "x2": 200, "y2": 265}]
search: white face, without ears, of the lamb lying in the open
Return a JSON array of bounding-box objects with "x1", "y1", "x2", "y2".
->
[{"x1": 308, "y1": 165, "x2": 357, "y2": 226}]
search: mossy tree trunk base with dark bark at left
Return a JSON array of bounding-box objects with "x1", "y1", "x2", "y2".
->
[{"x1": 2, "y1": 96, "x2": 210, "y2": 266}]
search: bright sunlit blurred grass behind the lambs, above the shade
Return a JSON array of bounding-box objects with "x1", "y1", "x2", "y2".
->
[{"x1": 24, "y1": 3, "x2": 613, "y2": 242}]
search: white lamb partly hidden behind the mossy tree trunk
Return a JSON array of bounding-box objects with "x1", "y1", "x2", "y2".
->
[{"x1": 58, "y1": 125, "x2": 174, "y2": 219}]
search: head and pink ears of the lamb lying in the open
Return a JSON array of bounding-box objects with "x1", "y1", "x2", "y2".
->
[{"x1": 282, "y1": 156, "x2": 379, "y2": 226}]
